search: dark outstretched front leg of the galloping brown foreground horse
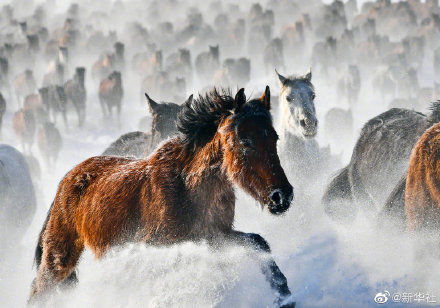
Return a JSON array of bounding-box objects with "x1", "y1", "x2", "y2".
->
[{"x1": 232, "y1": 231, "x2": 295, "y2": 307}]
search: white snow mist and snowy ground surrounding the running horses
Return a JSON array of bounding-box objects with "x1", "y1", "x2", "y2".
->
[{"x1": 0, "y1": 0, "x2": 440, "y2": 307}]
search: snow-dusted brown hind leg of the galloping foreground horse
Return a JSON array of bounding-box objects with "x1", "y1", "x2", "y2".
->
[{"x1": 29, "y1": 226, "x2": 84, "y2": 301}]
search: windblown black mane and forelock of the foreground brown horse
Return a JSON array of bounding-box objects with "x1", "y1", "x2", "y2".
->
[{"x1": 176, "y1": 88, "x2": 271, "y2": 150}]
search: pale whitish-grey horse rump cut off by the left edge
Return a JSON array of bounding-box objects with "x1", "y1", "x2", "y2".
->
[{"x1": 0, "y1": 144, "x2": 36, "y2": 248}]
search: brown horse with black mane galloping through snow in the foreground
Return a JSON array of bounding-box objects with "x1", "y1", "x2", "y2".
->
[{"x1": 31, "y1": 87, "x2": 293, "y2": 306}]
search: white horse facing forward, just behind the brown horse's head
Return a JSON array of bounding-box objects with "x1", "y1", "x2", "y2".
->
[{"x1": 276, "y1": 71, "x2": 337, "y2": 199}]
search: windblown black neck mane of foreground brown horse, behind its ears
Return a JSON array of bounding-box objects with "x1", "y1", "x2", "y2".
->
[{"x1": 176, "y1": 88, "x2": 235, "y2": 150}]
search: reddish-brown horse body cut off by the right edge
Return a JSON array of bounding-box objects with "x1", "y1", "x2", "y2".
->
[{"x1": 405, "y1": 123, "x2": 440, "y2": 230}]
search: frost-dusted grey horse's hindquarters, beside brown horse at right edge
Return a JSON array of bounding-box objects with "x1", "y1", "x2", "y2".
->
[{"x1": 322, "y1": 104, "x2": 440, "y2": 219}]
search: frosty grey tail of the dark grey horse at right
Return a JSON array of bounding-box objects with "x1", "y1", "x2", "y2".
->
[{"x1": 321, "y1": 166, "x2": 353, "y2": 220}]
